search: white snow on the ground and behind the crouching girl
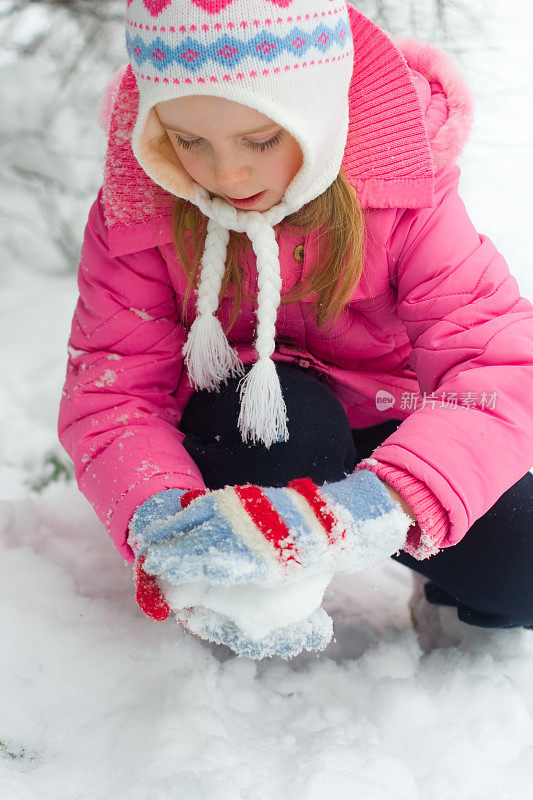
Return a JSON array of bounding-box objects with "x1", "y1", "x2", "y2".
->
[{"x1": 0, "y1": 0, "x2": 533, "y2": 800}]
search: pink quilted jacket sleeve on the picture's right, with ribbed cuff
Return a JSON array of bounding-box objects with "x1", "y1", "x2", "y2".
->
[{"x1": 360, "y1": 165, "x2": 533, "y2": 558}]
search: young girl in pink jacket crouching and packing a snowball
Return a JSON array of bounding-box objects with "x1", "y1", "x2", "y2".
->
[{"x1": 59, "y1": 0, "x2": 533, "y2": 657}]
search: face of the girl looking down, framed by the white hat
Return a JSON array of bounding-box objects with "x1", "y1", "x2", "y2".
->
[{"x1": 156, "y1": 95, "x2": 303, "y2": 211}]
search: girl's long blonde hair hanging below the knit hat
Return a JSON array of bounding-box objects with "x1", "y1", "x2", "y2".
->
[{"x1": 172, "y1": 168, "x2": 365, "y2": 334}]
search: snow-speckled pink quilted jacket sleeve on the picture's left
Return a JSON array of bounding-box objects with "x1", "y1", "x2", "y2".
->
[{"x1": 58, "y1": 191, "x2": 204, "y2": 562}]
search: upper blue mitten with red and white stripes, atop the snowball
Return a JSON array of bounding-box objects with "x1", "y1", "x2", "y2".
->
[{"x1": 130, "y1": 470, "x2": 414, "y2": 586}]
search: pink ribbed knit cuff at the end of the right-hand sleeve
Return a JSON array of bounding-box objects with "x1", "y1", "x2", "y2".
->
[{"x1": 354, "y1": 458, "x2": 450, "y2": 561}]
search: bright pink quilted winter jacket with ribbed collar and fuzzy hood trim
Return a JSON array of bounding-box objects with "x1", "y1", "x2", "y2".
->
[{"x1": 59, "y1": 8, "x2": 533, "y2": 562}]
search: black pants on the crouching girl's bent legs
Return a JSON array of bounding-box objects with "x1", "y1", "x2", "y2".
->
[{"x1": 180, "y1": 362, "x2": 533, "y2": 628}]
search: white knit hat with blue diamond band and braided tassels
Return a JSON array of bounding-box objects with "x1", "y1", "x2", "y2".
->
[{"x1": 126, "y1": 0, "x2": 353, "y2": 447}]
